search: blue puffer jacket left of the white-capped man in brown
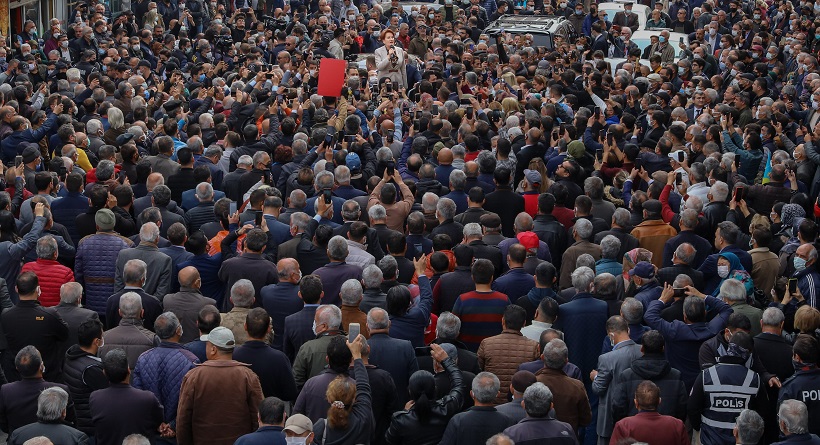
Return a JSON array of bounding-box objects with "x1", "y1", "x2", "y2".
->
[{"x1": 131, "y1": 341, "x2": 199, "y2": 429}]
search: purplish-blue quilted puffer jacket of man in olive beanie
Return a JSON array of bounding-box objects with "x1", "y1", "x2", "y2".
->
[{"x1": 74, "y1": 232, "x2": 134, "y2": 316}]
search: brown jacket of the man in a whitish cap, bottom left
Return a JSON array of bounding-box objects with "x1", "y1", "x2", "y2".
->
[{"x1": 176, "y1": 360, "x2": 263, "y2": 445}]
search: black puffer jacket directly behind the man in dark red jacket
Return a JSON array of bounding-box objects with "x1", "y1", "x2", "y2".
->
[{"x1": 609, "y1": 354, "x2": 689, "y2": 422}]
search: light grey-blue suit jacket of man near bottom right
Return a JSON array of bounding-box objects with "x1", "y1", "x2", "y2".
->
[{"x1": 592, "y1": 340, "x2": 641, "y2": 437}]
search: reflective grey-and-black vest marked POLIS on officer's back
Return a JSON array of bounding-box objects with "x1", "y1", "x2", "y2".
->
[{"x1": 701, "y1": 363, "x2": 760, "y2": 445}]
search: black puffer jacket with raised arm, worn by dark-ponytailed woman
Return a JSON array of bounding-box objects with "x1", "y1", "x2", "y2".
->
[{"x1": 385, "y1": 358, "x2": 468, "y2": 445}]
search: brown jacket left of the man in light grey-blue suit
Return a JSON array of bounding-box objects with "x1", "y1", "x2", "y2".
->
[{"x1": 535, "y1": 367, "x2": 592, "y2": 430}]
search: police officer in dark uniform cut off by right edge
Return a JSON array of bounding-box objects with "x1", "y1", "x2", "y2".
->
[{"x1": 777, "y1": 335, "x2": 820, "y2": 434}]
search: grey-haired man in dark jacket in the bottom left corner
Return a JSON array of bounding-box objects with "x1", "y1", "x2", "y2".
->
[{"x1": 8, "y1": 386, "x2": 88, "y2": 445}]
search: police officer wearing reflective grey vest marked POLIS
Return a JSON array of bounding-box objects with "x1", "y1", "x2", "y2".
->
[{"x1": 687, "y1": 331, "x2": 768, "y2": 445}]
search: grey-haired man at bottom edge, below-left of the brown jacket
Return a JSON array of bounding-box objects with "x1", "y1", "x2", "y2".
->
[{"x1": 504, "y1": 380, "x2": 578, "y2": 444}]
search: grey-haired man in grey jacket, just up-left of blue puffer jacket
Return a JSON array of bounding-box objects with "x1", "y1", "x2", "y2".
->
[{"x1": 99, "y1": 292, "x2": 160, "y2": 369}]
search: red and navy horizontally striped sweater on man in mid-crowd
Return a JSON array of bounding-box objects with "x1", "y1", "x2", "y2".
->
[{"x1": 453, "y1": 291, "x2": 512, "y2": 352}]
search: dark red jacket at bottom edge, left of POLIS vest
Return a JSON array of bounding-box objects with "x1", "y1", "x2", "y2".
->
[{"x1": 609, "y1": 411, "x2": 689, "y2": 445}]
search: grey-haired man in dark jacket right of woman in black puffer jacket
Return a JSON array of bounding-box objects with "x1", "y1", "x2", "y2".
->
[{"x1": 441, "y1": 372, "x2": 514, "y2": 444}]
